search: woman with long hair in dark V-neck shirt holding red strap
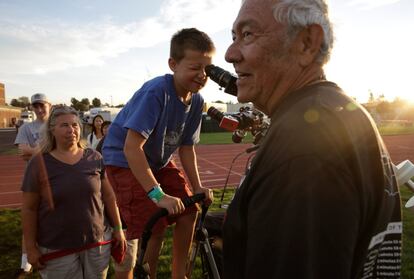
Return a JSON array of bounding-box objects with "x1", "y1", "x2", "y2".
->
[{"x1": 22, "y1": 105, "x2": 126, "y2": 279}]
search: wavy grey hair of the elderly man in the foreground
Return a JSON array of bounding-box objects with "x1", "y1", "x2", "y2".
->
[{"x1": 273, "y1": 0, "x2": 334, "y2": 64}]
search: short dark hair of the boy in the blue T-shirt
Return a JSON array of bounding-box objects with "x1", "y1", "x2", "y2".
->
[{"x1": 170, "y1": 28, "x2": 216, "y2": 62}]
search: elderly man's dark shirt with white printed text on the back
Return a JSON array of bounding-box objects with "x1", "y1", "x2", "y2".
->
[{"x1": 223, "y1": 82, "x2": 402, "y2": 279}]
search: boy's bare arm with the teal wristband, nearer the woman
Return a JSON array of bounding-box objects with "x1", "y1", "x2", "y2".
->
[{"x1": 124, "y1": 129, "x2": 185, "y2": 214}]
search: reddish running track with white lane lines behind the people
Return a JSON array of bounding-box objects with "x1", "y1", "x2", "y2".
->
[{"x1": 0, "y1": 135, "x2": 414, "y2": 208}]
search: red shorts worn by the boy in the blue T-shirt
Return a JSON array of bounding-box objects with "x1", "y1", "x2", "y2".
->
[{"x1": 106, "y1": 161, "x2": 198, "y2": 240}]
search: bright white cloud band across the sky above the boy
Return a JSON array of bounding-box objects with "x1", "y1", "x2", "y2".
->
[{"x1": 0, "y1": 0, "x2": 240, "y2": 74}]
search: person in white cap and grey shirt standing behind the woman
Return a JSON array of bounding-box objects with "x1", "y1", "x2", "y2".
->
[{"x1": 14, "y1": 93, "x2": 51, "y2": 273}]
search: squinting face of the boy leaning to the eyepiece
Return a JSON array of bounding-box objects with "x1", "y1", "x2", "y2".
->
[{"x1": 168, "y1": 49, "x2": 212, "y2": 96}]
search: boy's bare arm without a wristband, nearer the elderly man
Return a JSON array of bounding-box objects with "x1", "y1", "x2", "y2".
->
[{"x1": 178, "y1": 145, "x2": 213, "y2": 203}]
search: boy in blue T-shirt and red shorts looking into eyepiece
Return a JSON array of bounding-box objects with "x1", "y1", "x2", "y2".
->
[{"x1": 103, "y1": 28, "x2": 215, "y2": 279}]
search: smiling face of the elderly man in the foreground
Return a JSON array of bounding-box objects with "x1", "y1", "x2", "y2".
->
[{"x1": 225, "y1": 0, "x2": 293, "y2": 112}]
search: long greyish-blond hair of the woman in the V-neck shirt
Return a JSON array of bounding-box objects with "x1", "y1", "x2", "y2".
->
[{"x1": 40, "y1": 105, "x2": 86, "y2": 153}]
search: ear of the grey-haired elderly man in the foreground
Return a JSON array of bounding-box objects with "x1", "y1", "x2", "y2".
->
[{"x1": 298, "y1": 24, "x2": 324, "y2": 67}]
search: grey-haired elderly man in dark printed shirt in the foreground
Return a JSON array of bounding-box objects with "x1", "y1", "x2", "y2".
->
[{"x1": 223, "y1": 0, "x2": 402, "y2": 279}]
